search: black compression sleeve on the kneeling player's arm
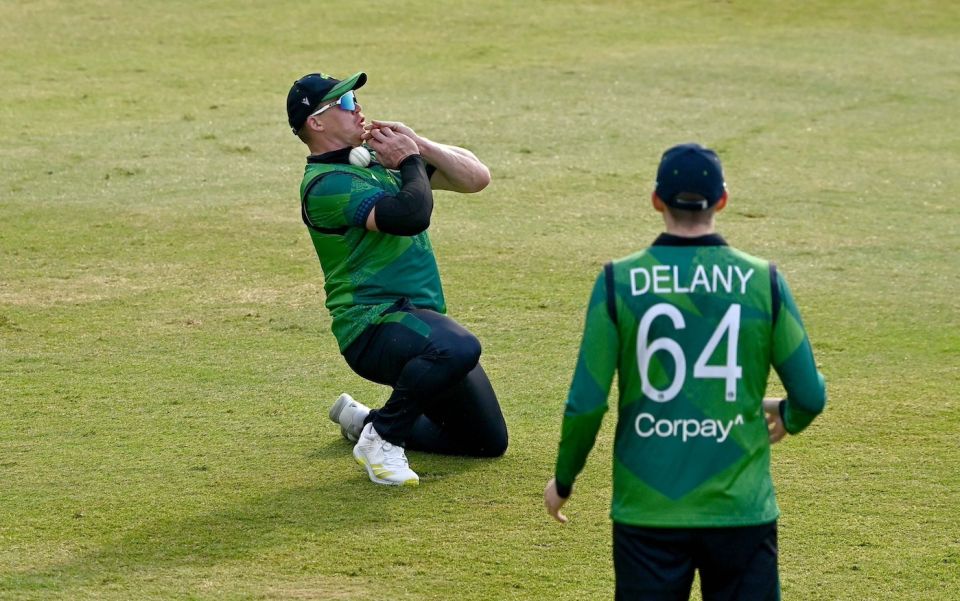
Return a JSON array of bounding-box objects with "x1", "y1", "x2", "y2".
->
[{"x1": 374, "y1": 154, "x2": 433, "y2": 236}]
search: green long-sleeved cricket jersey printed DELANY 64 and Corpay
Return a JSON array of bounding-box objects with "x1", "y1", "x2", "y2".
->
[{"x1": 556, "y1": 234, "x2": 826, "y2": 528}]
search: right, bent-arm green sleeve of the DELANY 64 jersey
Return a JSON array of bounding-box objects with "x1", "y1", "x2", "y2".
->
[{"x1": 773, "y1": 273, "x2": 827, "y2": 434}]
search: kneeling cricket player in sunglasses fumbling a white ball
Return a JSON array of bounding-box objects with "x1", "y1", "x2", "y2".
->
[{"x1": 287, "y1": 68, "x2": 507, "y2": 486}]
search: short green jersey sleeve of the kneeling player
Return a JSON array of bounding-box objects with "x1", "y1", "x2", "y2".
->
[{"x1": 306, "y1": 172, "x2": 385, "y2": 228}]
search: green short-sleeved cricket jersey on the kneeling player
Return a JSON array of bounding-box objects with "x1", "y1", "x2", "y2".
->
[{"x1": 300, "y1": 149, "x2": 446, "y2": 352}]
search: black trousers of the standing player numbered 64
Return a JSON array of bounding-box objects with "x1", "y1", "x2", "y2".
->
[{"x1": 613, "y1": 522, "x2": 780, "y2": 601}]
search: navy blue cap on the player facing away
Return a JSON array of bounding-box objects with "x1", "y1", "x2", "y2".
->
[{"x1": 656, "y1": 143, "x2": 726, "y2": 211}]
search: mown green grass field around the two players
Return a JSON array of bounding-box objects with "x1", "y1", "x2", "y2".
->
[{"x1": 0, "y1": 0, "x2": 960, "y2": 601}]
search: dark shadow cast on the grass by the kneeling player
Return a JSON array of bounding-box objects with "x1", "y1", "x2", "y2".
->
[{"x1": 11, "y1": 440, "x2": 497, "y2": 590}]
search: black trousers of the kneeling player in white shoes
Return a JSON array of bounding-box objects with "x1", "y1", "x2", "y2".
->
[{"x1": 343, "y1": 299, "x2": 507, "y2": 457}]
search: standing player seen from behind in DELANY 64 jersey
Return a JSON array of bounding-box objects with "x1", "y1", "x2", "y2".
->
[{"x1": 544, "y1": 144, "x2": 826, "y2": 601}]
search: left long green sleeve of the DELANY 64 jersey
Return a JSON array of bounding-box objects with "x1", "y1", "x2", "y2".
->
[{"x1": 555, "y1": 272, "x2": 619, "y2": 496}]
